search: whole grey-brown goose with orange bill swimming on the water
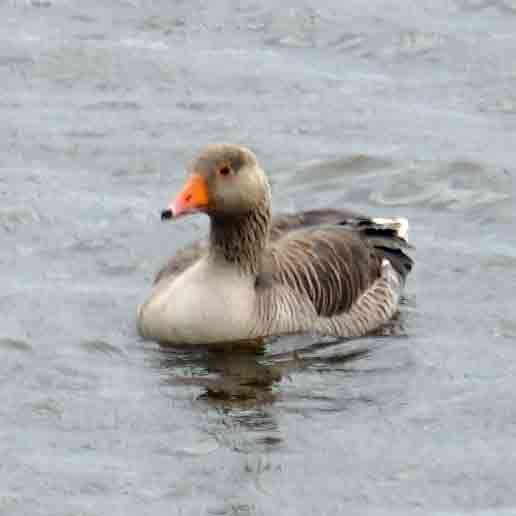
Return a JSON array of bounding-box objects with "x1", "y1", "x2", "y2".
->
[{"x1": 138, "y1": 144, "x2": 412, "y2": 344}]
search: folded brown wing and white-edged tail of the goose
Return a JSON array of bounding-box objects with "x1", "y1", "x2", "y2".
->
[{"x1": 257, "y1": 210, "x2": 413, "y2": 317}]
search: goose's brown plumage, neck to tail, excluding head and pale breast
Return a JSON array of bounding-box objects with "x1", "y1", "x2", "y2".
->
[{"x1": 152, "y1": 210, "x2": 413, "y2": 337}]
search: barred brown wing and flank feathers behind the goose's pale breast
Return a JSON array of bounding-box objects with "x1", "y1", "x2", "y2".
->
[{"x1": 251, "y1": 211, "x2": 412, "y2": 337}]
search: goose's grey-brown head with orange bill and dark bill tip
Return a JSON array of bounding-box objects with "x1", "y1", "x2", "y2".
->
[{"x1": 161, "y1": 143, "x2": 270, "y2": 220}]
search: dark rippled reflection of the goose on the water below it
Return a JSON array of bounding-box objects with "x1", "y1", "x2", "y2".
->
[{"x1": 151, "y1": 335, "x2": 369, "y2": 451}]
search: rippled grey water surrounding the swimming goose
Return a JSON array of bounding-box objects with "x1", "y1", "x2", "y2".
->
[{"x1": 0, "y1": 0, "x2": 516, "y2": 516}]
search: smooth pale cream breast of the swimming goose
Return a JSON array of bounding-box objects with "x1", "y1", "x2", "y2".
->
[{"x1": 138, "y1": 259, "x2": 254, "y2": 344}]
